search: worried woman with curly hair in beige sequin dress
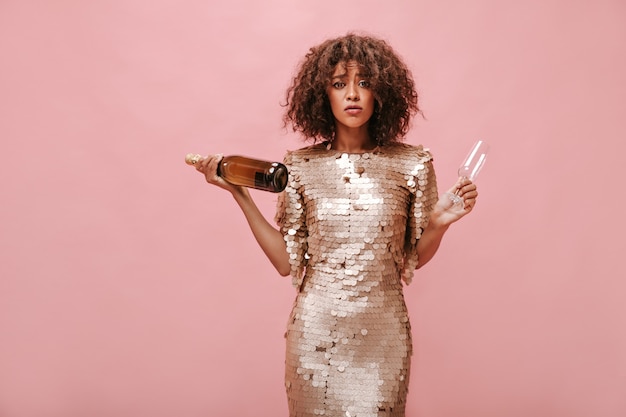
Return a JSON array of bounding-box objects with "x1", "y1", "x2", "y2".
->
[{"x1": 196, "y1": 34, "x2": 478, "y2": 417}]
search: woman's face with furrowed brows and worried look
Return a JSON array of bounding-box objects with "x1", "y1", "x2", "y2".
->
[{"x1": 326, "y1": 61, "x2": 375, "y2": 128}]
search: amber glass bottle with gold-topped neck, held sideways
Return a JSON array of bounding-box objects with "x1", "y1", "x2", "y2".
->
[{"x1": 185, "y1": 154, "x2": 289, "y2": 193}]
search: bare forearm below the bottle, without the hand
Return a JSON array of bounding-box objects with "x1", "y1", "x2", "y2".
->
[{"x1": 232, "y1": 187, "x2": 290, "y2": 276}]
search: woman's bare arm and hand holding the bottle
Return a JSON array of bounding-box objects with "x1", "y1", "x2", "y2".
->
[{"x1": 194, "y1": 155, "x2": 290, "y2": 276}]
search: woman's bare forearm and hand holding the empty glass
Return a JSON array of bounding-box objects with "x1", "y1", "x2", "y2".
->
[{"x1": 416, "y1": 178, "x2": 478, "y2": 269}]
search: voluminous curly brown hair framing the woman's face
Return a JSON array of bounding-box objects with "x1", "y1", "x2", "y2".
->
[{"x1": 283, "y1": 33, "x2": 420, "y2": 145}]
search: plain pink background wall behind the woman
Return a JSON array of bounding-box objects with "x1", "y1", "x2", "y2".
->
[{"x1": 0, "y1": 0, "x2": 626, "y2": 417}]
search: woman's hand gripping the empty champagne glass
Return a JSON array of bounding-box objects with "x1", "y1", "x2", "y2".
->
[{"x1": 431, "y1": 177, "x2": 478, "y2": 226}]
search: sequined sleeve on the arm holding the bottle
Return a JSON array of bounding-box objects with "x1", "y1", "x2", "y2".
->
[{"x1": 275, "y1": 152, "x2": 308, "y2": 287}]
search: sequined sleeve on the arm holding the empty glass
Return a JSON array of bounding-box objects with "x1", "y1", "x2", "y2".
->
[{"x1": 402, "y1": 149, "x2": 439, "y2": 284}]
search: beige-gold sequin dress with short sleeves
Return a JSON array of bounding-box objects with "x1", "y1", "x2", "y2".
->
[{"x1": 276, "y1": 143, "x2": 437, "y2": 417}]
